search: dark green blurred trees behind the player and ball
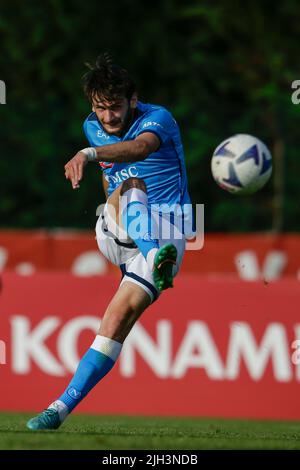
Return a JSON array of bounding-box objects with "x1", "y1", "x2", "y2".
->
[{"x1": 0, "y1": 0, "x2": 300, "y2": 233}]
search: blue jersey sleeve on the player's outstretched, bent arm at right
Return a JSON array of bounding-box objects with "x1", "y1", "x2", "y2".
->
[{"x1": 136, "y1": 108, "x2": 176, "y2": 144}]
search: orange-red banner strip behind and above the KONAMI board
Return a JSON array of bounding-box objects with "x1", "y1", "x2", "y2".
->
[{"x1": 0, "y1": 230, "x2": 300, "y2": 281}]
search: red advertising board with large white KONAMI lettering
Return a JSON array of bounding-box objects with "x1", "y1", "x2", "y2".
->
[{"x1": 0, "y1": 274, "x2": 300, "y2": 420}]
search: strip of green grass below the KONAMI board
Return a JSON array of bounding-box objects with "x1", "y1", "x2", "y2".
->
[{"x1": 0, "y1": 413, "x2": 300, "y2": 450}]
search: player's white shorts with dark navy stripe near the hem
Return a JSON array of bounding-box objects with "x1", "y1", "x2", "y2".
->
[{"x1": 96, "y1": 204, "x2": 186, "y2": 302}]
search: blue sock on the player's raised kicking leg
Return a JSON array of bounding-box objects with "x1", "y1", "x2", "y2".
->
[{"x1": 121, "y1": 188, "x2": 159, "y2": 260}]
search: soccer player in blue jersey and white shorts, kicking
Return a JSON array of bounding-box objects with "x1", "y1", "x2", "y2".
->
[{"x1": 27, "y1": 54, "x2": 190, "y2": 430}]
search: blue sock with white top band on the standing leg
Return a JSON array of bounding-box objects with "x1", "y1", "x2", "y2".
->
[{"x1": 58, "y1": 335, "x2": 122, "y2": 412}]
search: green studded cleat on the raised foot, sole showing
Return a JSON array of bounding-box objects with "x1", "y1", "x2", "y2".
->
[{"x1": 153, "y1": 243, "x2": 177, "y2": 292}]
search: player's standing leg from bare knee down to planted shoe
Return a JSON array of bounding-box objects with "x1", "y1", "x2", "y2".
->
[{"x1": 27, "y1": 282, "x2": 151, "y2": 430}]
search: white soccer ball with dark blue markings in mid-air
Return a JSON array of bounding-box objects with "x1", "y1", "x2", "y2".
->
[{"x1": 211, "y1": 134, "x2": 272, "y2": 194}]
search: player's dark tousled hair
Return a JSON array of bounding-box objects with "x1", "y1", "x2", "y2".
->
[{"x1": 83, "y1": 53, "x2": 136, "y2": 101}]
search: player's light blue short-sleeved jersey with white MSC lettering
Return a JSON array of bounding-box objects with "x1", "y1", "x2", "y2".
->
[{"x1": 83, "y1": 102, "x2": 191, "y2": 210}]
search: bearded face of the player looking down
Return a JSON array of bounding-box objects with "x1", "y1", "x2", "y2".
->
[{"x1": 92, "y1": 94, "x2": 137, "y2": 136}]
